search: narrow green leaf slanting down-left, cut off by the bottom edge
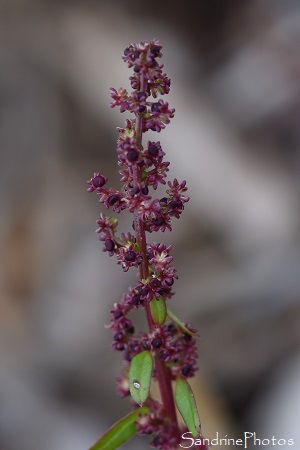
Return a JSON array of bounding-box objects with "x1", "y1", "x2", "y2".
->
[{"x1": 89, "y1": 407, "x2": 149, "y2": 450}]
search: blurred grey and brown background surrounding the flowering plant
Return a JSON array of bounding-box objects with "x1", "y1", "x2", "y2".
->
[{"x1": 0, "y1": 0, "x2": 300, "y2": 450}]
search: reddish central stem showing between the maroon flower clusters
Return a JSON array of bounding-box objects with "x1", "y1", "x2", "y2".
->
[{"x1": 133, "y1": 75, "x2": 179, "y2": 435}]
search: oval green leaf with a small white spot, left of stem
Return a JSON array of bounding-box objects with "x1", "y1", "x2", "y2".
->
[{"x1": 129, "y1": 350, "x2": 153, "y2": 406}]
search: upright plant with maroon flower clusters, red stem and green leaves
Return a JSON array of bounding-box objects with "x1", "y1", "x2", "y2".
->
[{"x1": 88, "y1": 39, "x2": 204, "y2": 450}]
